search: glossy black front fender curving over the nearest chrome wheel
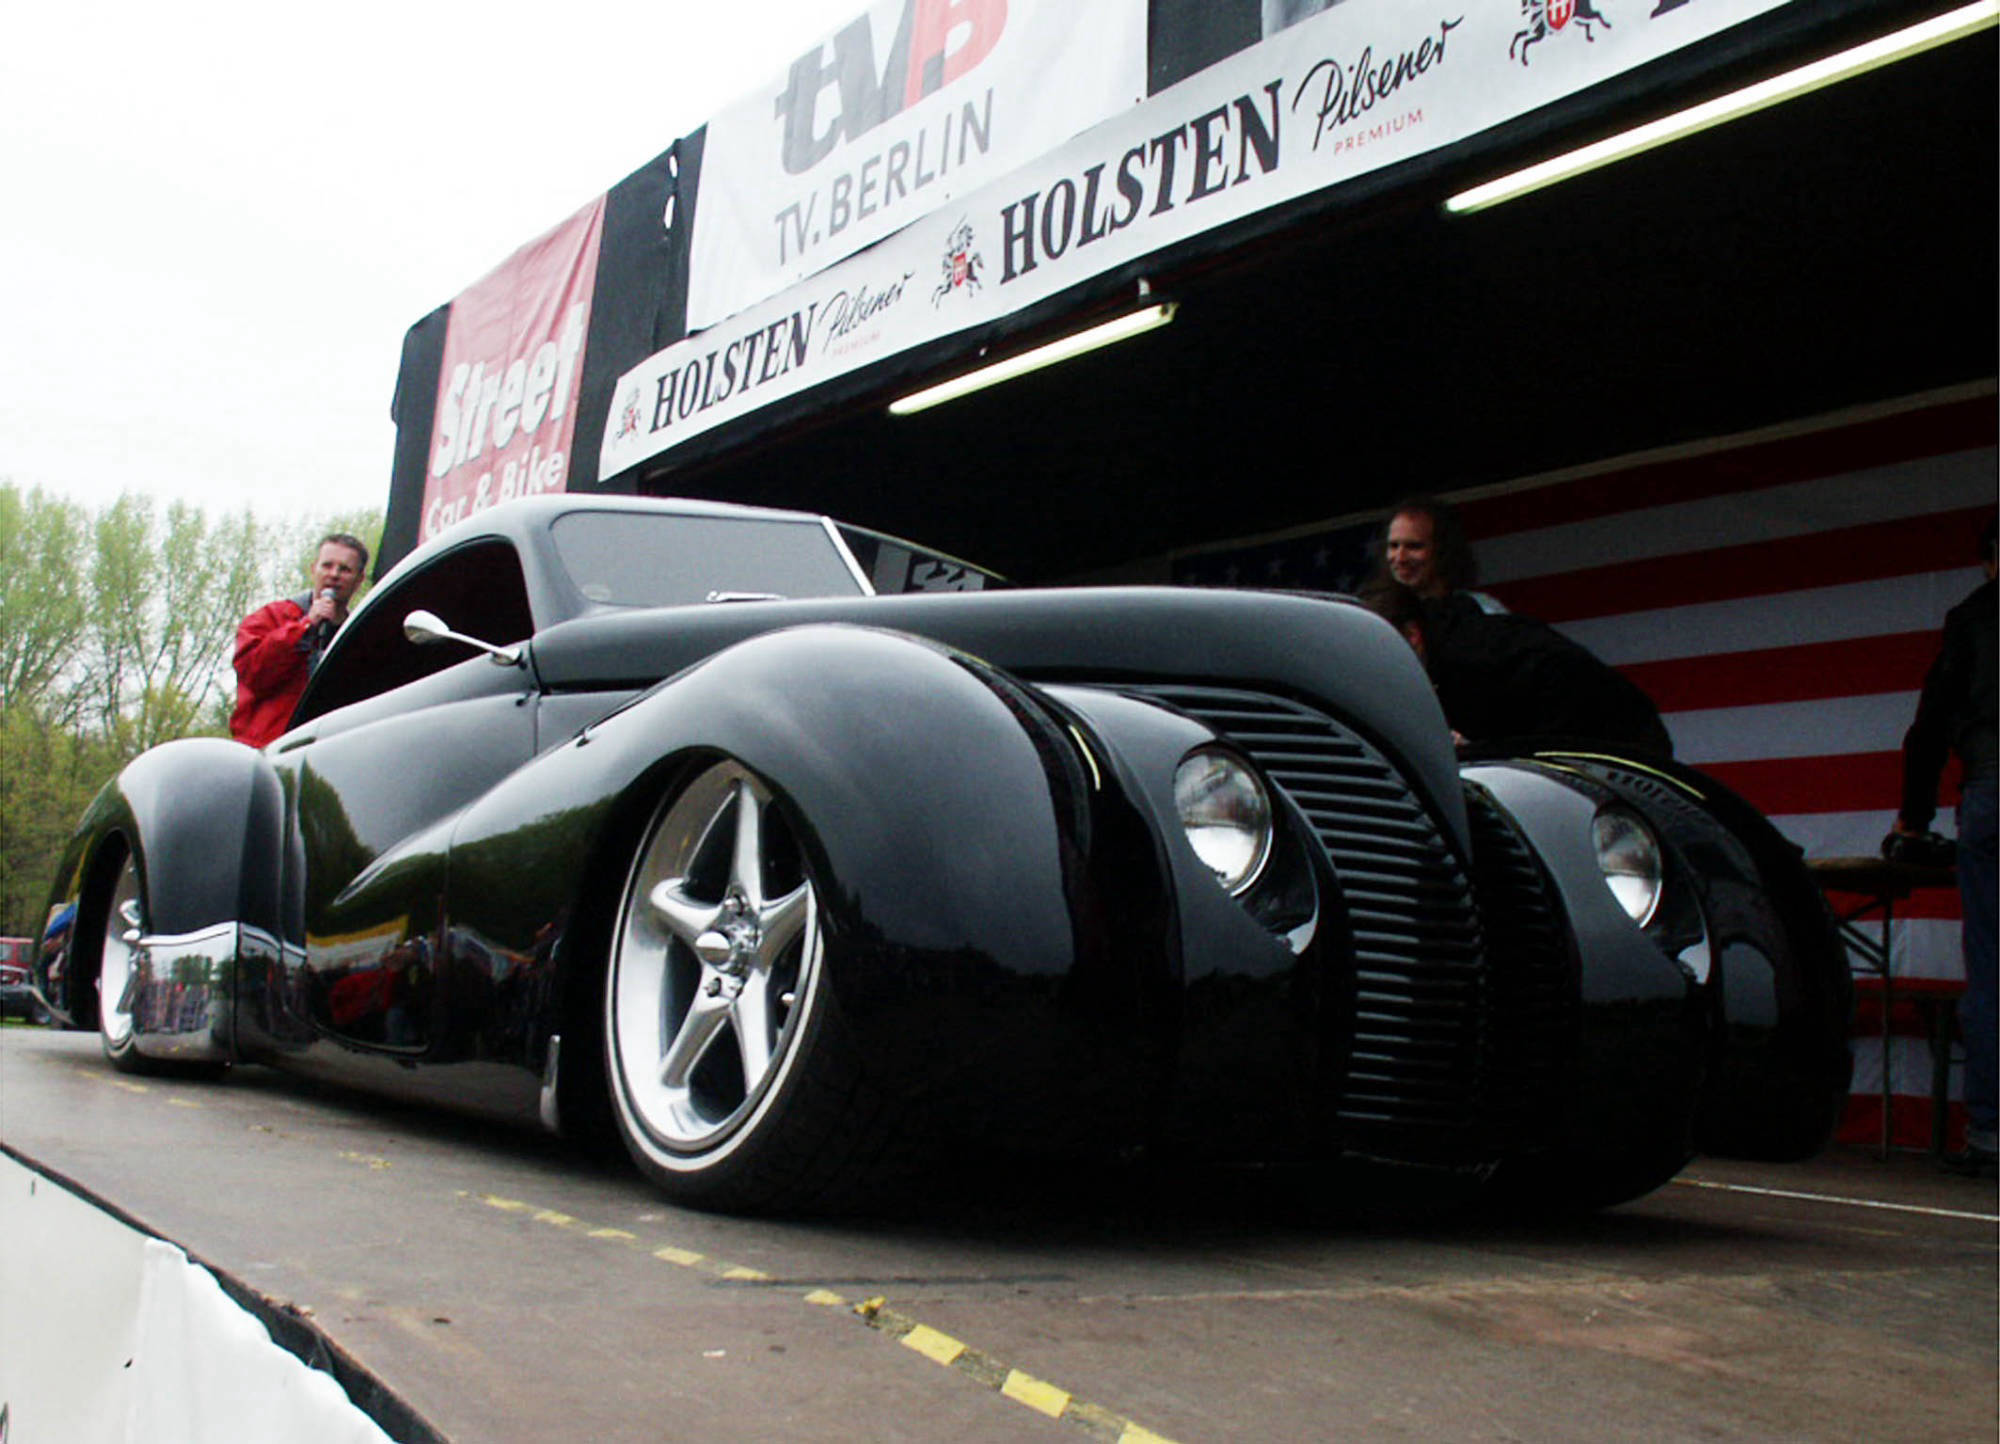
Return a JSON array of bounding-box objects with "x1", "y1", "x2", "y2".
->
[{"x1": 448, "y1": 626, "x2": 1172, "y2": 1144}]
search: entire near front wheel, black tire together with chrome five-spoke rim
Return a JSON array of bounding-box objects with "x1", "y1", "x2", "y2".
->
[{"x1": 604, "y1": 760, "x2": 888, "y2": 1212}]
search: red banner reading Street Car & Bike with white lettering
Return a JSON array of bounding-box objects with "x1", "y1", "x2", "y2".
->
[{"x1": 418, "y1": 196, "x2": 604, "y2": 542}]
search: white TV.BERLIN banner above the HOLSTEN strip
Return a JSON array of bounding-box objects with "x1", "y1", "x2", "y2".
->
[{"x1": 688, "y1": 0, "x2": 1146, "y2": 328}]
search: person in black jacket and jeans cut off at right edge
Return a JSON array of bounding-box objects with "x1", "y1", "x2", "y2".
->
[{"x1": 1882, "y1": 518, "x2": 2000, "y2": 1176}]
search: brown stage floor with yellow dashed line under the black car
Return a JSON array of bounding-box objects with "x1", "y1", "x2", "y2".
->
[{"x1": 0, "y1": 1026, "x2": 2000, "y2": 1444}]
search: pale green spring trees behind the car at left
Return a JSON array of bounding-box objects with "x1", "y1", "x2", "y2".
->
[{"x1": 0, "y1": 480, "x2": 382, "y2": 934}]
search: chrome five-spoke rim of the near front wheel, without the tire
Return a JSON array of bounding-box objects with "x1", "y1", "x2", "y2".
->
[{"x1": 606, "y1": 762, "x2": 822, "y2": 1170}]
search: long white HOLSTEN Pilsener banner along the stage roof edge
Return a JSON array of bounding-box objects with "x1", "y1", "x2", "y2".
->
[{"x1": 600, "y1": 0, "x2": 1792, "y2": 476}]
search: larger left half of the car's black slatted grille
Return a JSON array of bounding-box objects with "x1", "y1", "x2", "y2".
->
[{"x1": 1136, "y1": 686, "x2": 1490, "y2": 1148}]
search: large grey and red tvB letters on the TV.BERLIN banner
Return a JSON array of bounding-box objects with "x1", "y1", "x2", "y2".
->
[{"x1": 774, "y1": 0, "x2": 1006, "y2": 176}]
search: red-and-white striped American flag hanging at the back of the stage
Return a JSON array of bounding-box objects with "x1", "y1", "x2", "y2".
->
[{"x1": 1176, "y1": 390, "x2": 2000, "y2": 1142}]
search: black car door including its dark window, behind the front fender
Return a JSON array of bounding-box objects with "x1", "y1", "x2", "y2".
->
[{"x1": 254, "y1": 538, "x2": 536, "y2": 1058}]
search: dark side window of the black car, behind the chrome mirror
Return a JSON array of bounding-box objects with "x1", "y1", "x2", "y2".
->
[{"x1": 292, "y1": 540, "x2": 534, "y2": 726}]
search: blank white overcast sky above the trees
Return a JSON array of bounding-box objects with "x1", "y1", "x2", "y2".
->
[{"x1": 0, "y1": 0, "x2": 868, "y2": 516}]
